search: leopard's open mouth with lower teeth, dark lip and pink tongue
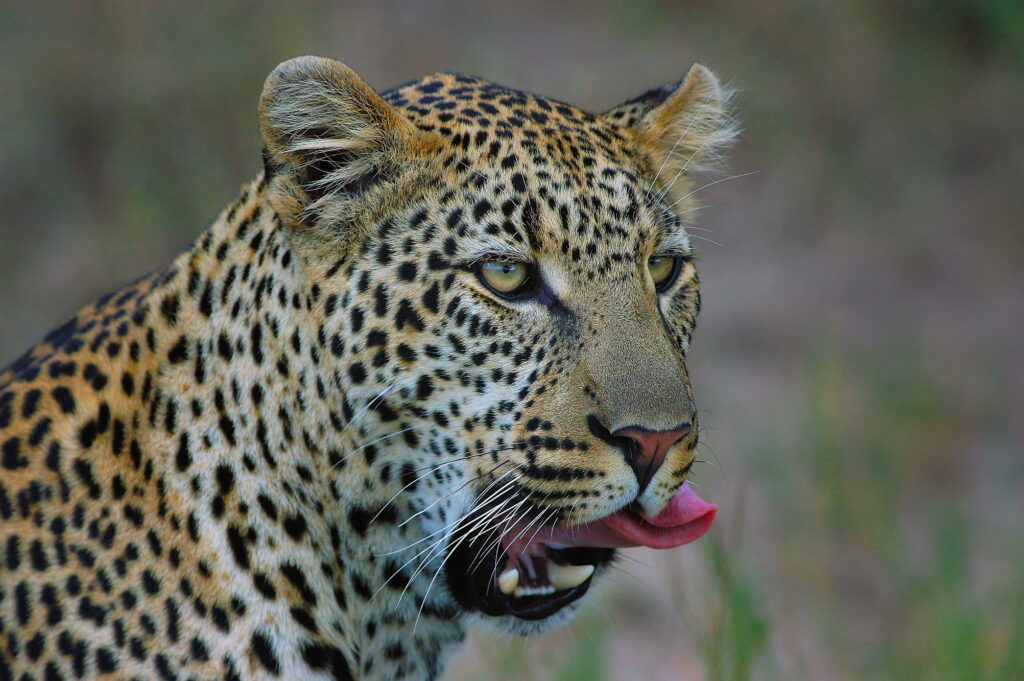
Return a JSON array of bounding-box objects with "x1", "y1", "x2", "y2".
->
[{"x1": 444, "y1": 484, "x2": 718, "y2": 620}]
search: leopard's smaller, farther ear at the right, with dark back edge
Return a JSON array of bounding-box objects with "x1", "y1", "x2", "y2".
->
[{"x1": 602, "y1": 63, "x2": 738, "y2": 201}]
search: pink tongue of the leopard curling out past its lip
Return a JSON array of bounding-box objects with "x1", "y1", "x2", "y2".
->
[{"x1": 530, "y1": 484, "x2": 718, "y2": 549}]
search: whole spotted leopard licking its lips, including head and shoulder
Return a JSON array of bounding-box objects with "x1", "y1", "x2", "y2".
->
[{"x1": 0, "y1": 56, "x2": 737, "y2": 681}]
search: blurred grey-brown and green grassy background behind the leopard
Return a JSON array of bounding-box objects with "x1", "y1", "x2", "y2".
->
[{"x1": 0, "y1": 0, "x2": 1024, "y2": 681}]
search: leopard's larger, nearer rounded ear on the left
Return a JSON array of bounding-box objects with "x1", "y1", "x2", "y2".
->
[{"x1": 259, "y1": 56, "x2": 429, "y2": 233}]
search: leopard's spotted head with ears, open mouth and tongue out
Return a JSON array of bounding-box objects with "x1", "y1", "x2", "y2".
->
[{"x1": 260, "y1": 57, "x2": 735, "y2": 633}]
